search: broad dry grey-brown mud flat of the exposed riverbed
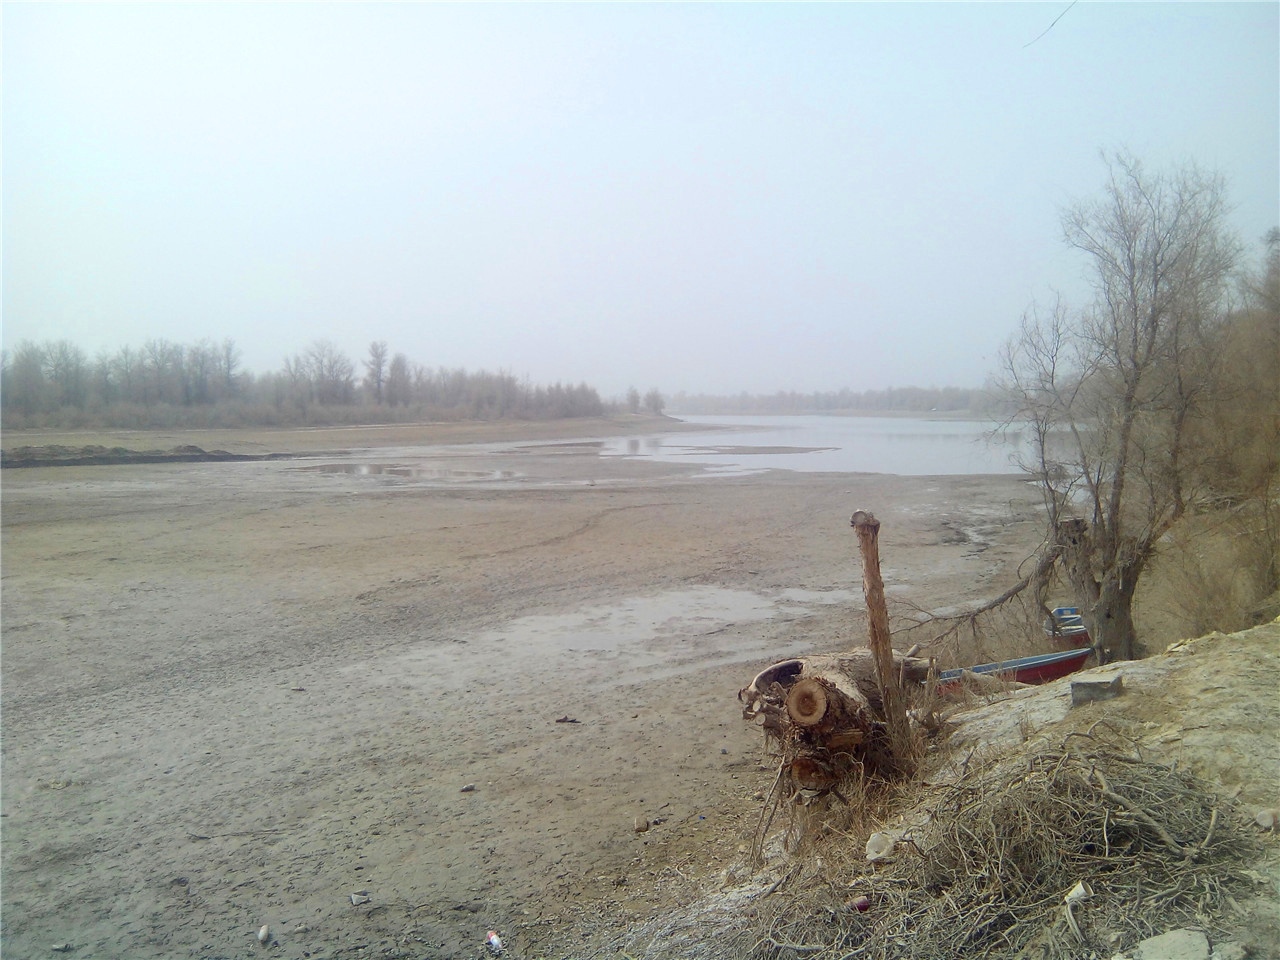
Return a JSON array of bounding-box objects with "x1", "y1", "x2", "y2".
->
[{"x1": 0, "y1": 425, "x2": 1038, "y2": 959}]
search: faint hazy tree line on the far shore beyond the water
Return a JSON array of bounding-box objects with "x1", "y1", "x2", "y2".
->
[{"x1": 671, "y1": 387, "x2": 991, "y2": 415}]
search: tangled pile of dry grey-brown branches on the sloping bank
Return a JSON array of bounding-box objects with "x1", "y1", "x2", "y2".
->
[{"x1": 735, "y1": 733, "x2": 1261, "y2": 960}]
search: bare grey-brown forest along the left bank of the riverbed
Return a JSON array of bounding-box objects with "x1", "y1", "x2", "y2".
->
[{"x1": 0, "y1": 339, "x2": 609, "y2": 429}]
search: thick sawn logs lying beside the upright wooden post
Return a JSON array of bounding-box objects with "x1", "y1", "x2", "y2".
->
[{"x1": 737, "y1": 648, "x2": 929, "y2": 794}]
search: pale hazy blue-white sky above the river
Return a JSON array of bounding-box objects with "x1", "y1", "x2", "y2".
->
[{"x1": 3, "y1": 1, "x2": 1280, "y2": 396}]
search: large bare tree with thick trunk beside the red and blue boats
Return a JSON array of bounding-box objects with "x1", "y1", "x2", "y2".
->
[{"x1": 1002, "y1": 156, "x2": 1239, "y2": 659}]
